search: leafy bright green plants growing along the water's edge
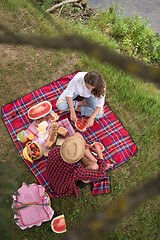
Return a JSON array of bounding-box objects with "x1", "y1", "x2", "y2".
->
[{"x1": 89, "y1": 5, "x2": 160, "y2": 64}]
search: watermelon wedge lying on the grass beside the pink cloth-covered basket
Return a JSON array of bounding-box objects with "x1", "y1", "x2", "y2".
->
[{"x1": 51, "y1": 215, "x2": 67, "y2": 233}]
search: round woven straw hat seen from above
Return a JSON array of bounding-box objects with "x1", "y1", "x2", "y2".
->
[{"x1": 60, "y1": 137, "x2": 85, "y2": 163}]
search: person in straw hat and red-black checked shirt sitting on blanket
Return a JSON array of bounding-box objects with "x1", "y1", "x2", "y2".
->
[{"x1": 46, "y1": 132, "x2": 113, "y2": 197}]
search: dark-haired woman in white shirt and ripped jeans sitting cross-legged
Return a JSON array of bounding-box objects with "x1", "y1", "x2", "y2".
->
[{"x1": 56, "y1": 71, "x2": 106, "y2": 128}]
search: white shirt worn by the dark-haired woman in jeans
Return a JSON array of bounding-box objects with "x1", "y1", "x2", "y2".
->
[{"x1": 65, "y1": 72, "x2": 105, "y2": 107}]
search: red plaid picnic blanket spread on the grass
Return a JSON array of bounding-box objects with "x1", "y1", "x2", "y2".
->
[{"x1": 1, "y1": 72, "x2": 137, "y2": 197}]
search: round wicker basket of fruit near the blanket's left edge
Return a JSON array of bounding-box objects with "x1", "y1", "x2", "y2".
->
[{"x1": 23, "y1": 142, "x2": 44, "y2": 163}]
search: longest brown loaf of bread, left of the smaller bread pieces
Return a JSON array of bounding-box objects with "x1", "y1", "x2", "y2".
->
[{"x1": 45, "y1": 122, "x2": 59, "y2": 148}]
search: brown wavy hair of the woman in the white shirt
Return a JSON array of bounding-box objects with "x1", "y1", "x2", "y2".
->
[{"x1": 84, "y1": 71, "x2": 106, "y2": 98}]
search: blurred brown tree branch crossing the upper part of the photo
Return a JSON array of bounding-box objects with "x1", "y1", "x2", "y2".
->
[{"x1": 0, "y1": 25, "x2": 160, "y2": 86}]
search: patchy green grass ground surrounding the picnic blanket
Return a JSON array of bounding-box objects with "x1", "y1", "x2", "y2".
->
[{"x1": 0, "y1": 0, "x2": 160, "y2": 240}]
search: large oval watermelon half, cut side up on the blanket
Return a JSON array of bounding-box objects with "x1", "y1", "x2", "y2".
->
[{"x1": 28, "y1": 101, "x2": 52, "y2": 120}]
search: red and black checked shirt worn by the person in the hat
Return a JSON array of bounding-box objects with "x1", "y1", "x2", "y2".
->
[{"x1": 46, "y1": 147, "x2": 106, "y2": 197}]
